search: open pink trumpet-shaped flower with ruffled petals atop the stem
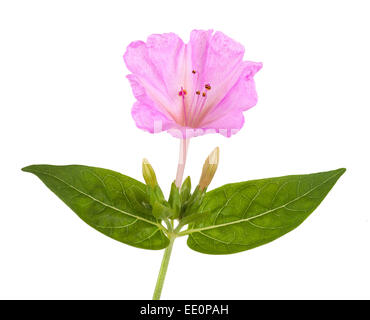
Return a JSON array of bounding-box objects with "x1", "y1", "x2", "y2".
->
[{"x1": 124, "y1": 30, "x2": 262, "y2": 138}]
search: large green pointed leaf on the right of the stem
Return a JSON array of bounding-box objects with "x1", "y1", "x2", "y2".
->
[{"x1": 186, "y1": 169, "x2": 345, "y2": 254}]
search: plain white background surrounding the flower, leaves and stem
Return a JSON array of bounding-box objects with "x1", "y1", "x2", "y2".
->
[{"x1": 0, "y1": 0, "x2": 370, "y2": 299}]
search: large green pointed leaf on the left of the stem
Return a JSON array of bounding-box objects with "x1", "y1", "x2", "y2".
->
[{"x1": 22, "y1": 165, "x2": 169, "y2": 250}]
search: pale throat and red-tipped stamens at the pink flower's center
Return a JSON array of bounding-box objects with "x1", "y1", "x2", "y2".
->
[{"x1": 179, "y1": 70, "x2": 212, "y2": 128}]
